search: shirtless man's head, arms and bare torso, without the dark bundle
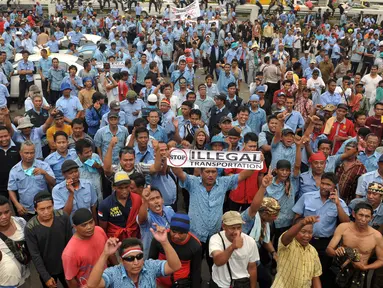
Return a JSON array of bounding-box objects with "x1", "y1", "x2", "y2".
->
[{"x1": 326, "y1": 203, "x2": 383, "y2": 286}]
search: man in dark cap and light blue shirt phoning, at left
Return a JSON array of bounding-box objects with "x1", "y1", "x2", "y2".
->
[{"x1": 52, "y1": 159, "x2": 97, "y2": 221}]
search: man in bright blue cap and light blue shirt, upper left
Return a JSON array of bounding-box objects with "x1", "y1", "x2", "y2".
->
[{"x1": 52, "y1": 82, "x2": 84, "y2": 124}]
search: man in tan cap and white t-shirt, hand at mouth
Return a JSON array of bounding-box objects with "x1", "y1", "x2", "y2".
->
[{"x1": 209, "y1": 211, "x2": 259, "y2": 287}]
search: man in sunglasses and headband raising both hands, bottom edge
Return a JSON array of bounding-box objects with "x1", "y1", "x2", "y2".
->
[{"x1": 87, "y1": 225, "x2": 181, "y2": 288}]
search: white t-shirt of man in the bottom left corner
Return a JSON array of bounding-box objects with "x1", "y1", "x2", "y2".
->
[{"x1": 0, "y1": 216, "x2": 30, "y2": 287}]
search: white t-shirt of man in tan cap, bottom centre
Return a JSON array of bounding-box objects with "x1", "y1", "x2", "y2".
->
[{"x1": 209, "y1": 231, "x2": 259, "y2": 288}]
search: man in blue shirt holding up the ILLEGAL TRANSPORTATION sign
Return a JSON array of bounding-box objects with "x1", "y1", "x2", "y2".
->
[{"x1": 172, "y1": 158, "x2": 254, "y2": 271}]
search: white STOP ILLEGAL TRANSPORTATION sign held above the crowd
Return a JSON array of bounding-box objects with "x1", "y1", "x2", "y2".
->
[{"x1": 168, "y1": 148, "x2": 263, "y2": 170}]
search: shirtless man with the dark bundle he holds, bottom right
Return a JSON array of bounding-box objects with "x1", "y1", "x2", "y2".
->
[{"x1": 326, "y1": 203, "x2": 383, "y2": 287}]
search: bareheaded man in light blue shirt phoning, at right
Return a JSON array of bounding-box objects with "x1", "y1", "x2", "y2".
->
[{"x1": 292, "y1": 173, "x2": 350, "y2": 287}]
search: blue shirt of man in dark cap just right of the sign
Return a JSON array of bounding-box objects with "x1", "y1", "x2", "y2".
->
[{"x1": 265, "y1": 177, "x2": 298, "y2": 228}]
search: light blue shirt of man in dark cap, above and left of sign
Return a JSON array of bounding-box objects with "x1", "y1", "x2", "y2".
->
[{"x1": 94, "y1": 125, "x2": 129, "y2": 165}]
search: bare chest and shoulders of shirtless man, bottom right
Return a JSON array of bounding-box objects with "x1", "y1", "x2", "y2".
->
[{"x1": 339, "y1": 222, "x2": 382, "y2": 265}]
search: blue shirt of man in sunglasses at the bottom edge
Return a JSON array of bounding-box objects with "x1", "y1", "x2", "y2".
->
[{"x1": 102, "y1": 259, "x2": 166, "y2": 288}]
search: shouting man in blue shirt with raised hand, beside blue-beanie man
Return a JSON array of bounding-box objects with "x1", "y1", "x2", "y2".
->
[{"x1": 137, "y1": 185, "x2": 174, "y2": 259}]
